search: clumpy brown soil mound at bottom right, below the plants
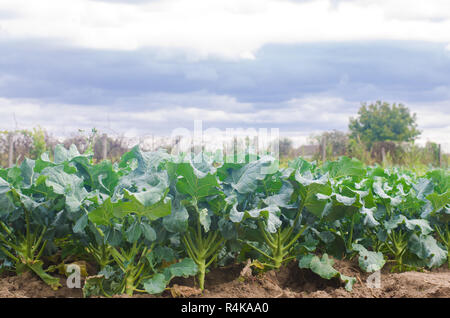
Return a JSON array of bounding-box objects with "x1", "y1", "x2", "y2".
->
[{"x1": 170, "y1": 260, "x2": 450, "y2": 298}]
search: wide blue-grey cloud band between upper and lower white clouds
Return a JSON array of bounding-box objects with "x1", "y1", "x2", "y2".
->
[{"x1": 0, "y1": 41, "x2": 450, "y2": 118}]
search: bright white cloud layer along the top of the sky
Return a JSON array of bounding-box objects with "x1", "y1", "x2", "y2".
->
[{"x1": 0, "y1": 0, "x2": 450, "y2": 59}]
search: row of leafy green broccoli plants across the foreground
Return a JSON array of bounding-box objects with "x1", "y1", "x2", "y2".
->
[{"x1": 0, "y1": 146, "x2": 450, "y2": 296}]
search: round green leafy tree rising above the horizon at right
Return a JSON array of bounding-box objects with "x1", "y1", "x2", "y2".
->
[{"x1": 349, "y1": 101, "x2": 420, "y2": 148}]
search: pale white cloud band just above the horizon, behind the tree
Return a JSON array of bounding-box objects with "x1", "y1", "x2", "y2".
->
[{"x1": 0, "y1": 92, "x2": 450, "y2": 152}]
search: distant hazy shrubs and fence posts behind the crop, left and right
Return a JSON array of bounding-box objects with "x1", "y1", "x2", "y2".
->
[{"x1": 0, "y1": 127, "x2": 450, "y2": 168}]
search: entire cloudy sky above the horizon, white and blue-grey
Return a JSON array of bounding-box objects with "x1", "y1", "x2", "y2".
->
[{"x1": 0, "y1": 0, "x2": 450, "y2": 148}]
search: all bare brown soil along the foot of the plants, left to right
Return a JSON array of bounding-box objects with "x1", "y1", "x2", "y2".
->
[{"x1": 0, "y1": 260, "x2": 450, "y2": 298}]
